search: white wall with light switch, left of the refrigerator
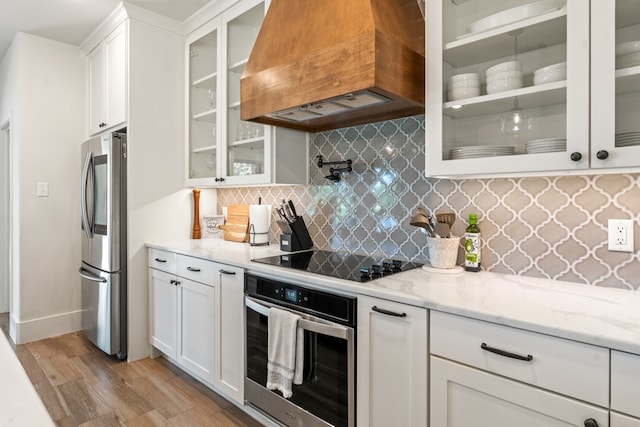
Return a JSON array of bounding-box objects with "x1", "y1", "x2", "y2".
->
[{"x1": 0, "y1": 33, "x2": 85, "y2": 343}]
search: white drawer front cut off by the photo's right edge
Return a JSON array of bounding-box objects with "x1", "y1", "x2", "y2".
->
[{"x1": 611, "y1": 351, "x2": 640, "y2": 417}]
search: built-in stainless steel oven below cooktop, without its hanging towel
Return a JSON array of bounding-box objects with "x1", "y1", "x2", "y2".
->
[{"x1": 245, "y1": 274, "x2": 356, "y2": 427}]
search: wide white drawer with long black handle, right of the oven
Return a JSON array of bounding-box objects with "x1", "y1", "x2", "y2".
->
[{"x1": 431, "y1": 311, "x2": 609, "y2": 406}]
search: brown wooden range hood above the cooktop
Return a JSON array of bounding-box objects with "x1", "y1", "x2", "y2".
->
[{"x1": 240, "y1": 0, "x2": 425, "y2": 132}]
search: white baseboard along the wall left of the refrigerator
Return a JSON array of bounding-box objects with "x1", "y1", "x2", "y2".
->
[{"x1": 10, "y1": 310, "x2": 81, "y2": 344}]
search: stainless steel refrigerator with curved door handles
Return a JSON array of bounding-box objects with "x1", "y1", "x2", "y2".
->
[{"x1": 80, "y1": 133, "x2": 127, "y2": 359}]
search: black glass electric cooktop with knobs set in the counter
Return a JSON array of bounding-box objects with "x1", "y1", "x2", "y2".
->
[{"x1": 252, "y1": 250, "x2": 422, "y2": 282}]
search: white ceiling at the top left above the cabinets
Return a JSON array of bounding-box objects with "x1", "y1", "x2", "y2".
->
[{"x1": 0, "y1": 0, "x2": 216, "y2": 60}]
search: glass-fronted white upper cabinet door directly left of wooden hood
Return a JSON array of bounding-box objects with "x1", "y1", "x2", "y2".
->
[{"x1": 221, "y1": 0, "x2": 272, "y2": 185}]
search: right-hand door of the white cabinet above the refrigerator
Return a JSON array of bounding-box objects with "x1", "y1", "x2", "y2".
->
[{"x1": 105, "y1": 22, "x2": 127, "y2": 131}]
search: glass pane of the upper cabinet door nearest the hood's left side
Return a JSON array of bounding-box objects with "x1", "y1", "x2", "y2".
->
[{"x1": 225, "y1": 2, "x2": 266, "y2": 180}]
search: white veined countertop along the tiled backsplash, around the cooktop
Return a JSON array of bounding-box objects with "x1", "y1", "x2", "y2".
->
[{"x1": 147, "y1": 239, "x2": 640, "y2": 354}]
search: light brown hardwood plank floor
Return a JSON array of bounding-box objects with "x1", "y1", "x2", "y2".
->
[{"x1": 0, "y1": 314, "x2": 261, "y2": 427}]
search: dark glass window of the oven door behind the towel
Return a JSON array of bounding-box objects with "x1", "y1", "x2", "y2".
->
[{"x1": 246, "y1": 308, "x2": 348, "y2": 427}]
